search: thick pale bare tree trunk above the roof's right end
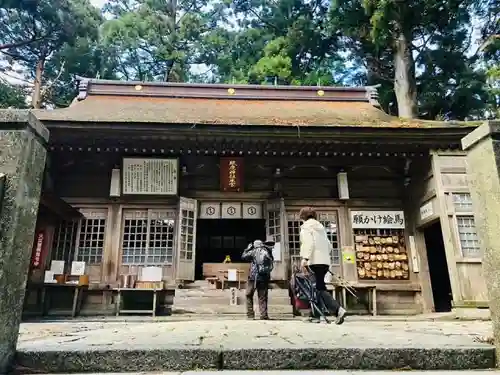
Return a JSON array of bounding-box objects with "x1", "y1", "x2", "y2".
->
[{"x1": 394, "y1": 33, "x2": 418, "y2": 118}]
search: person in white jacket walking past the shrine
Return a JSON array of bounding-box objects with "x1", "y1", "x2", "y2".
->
[{"x1": 299, "y1": 207, "x2": 346, "y2": 324}]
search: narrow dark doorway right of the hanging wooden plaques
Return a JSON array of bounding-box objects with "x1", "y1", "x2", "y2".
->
[{"x1": 424, "y1": 221, "x2": 453, "y2": 312}]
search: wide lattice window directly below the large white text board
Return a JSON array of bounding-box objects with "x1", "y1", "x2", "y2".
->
[{"x1": 120, "y1": 207, "x2": 178, "y2": 266}]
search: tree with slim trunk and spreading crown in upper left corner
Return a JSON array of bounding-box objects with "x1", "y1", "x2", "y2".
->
[{"x1": 0, "y1": 0, "x2": 101, "y2": 108}]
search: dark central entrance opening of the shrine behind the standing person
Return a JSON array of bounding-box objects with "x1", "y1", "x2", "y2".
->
[{"x1": 195, "y1": 219, "x2": 266, "y2": 280}]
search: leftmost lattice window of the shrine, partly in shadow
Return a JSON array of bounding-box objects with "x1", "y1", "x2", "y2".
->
[{"x1": 51, "y1": 208, "x2": 108, "y2": 266}]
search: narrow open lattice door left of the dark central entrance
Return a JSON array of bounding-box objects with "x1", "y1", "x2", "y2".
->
[{"x1": 176, "y1": 197, "x2": 198, "y2": 281}]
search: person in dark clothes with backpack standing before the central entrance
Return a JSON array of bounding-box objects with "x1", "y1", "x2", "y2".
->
[{"x1": 241, "y1": 240, "x2": 274, "y2": 320}]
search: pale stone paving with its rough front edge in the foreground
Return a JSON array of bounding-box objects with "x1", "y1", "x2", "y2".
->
[{"x1": 16, "y1": 319, "x2": 494, "y2": 373}]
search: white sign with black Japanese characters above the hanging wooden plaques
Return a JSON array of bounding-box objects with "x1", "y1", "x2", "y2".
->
[{"x1": 351, "y1": 211, "x2": 405, "y2": 229}]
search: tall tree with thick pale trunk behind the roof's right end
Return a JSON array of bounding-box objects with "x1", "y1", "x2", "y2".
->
[{"x1": 331, "y1": 0, "x2": 480, "y2": 118}]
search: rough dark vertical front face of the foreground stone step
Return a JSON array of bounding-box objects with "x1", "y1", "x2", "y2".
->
[{"x1": 16, "y1": 348, "x2": 495, "y2": 373}]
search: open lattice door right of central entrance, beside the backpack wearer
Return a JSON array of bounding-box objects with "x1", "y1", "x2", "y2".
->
[{"x1": 266, "y1": 198, "x2": 289, "y2": 280}]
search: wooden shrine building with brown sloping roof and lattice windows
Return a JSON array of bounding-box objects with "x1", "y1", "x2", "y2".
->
[{"x1": 26, "y1": 78, "x2": 487, "y2": 314}]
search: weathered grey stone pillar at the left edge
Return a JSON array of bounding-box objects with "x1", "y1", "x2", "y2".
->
[{"x1": 0, "y1": 110, "x2": 49, "y2": 374}]
